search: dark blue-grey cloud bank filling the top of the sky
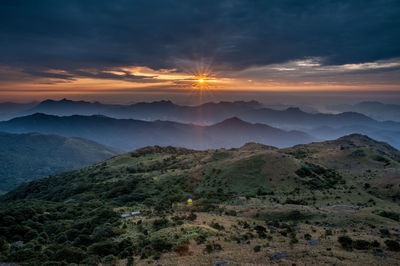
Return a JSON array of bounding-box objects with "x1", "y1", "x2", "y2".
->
[{"x1": 0, "y1": 0, "x2": 400, "y2": 77}]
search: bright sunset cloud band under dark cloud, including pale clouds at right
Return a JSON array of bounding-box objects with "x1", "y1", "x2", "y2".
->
[{"x1": 0, "y1": 58, "x2": 400, "y2": 102}]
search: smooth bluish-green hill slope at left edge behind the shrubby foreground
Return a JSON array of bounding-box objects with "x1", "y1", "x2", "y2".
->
[{"x1": 0, "y1": 132, "x2": 120, "y2": 194}]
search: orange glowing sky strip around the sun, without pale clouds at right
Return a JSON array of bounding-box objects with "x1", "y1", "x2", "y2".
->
[{"x1": 0, "y1": 62, "x2": 400, "y2": 101}]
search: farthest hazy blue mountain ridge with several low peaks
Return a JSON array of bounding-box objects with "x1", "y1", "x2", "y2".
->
[{"x1": 21, "y1": 99, "x2": 376, "y2": 127}]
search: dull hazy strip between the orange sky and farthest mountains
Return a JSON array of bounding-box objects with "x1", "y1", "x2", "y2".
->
[{"x1": 0, "y1": 90, "x2": 400, "y2": 108}]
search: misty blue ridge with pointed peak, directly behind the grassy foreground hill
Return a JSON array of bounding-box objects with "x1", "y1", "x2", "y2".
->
[{"x1": 0, "y1": 114, "x2": 315, "y2": 151}]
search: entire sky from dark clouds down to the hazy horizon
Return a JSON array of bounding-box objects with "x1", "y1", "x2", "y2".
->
[{"x1": 0, "y1": 0, "x2": 400, "y2": 103}]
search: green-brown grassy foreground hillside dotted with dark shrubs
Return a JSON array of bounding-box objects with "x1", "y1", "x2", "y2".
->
[{"x1": 0, "y1": 135, "x2": 400, "y2": 265}]
